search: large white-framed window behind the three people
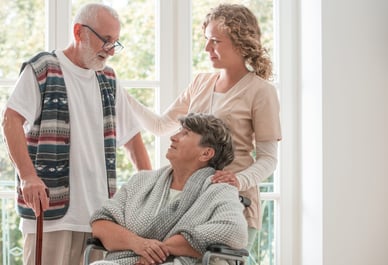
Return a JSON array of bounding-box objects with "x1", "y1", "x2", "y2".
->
[{"x1": 0, "y1": 0, "x2": 286, "y2": 265}]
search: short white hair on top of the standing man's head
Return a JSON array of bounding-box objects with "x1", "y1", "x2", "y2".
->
[{"x1": 73, "y1": 3, "x2": 119, "y2": 26}]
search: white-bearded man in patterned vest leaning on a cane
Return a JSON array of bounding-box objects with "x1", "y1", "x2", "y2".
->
[{"x1": 3, "y1": 3, "x2": 151, "y2": 265}]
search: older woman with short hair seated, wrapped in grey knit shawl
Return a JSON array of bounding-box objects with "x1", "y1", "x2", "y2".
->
[{"x1": 91, "y1": 114, "x2": 248, "y2": 265}]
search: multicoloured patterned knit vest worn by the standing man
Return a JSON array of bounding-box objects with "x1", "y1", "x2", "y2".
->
[{"x1": 17, "y1": 52, "x2": 116, "y2": 220}]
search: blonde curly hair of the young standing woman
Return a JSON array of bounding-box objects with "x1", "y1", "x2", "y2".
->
[{"x1": 202, "y1": 4, "x2": 273, "y2": 80}]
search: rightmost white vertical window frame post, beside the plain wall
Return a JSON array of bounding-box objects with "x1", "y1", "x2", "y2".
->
[{"x1": 274, "y1": 0, "x2": 301, "y2": 265}]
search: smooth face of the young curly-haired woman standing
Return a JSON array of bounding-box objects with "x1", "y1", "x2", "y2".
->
[{"x1": 205, "y1": 20, "x2": 243, "y2": 69}]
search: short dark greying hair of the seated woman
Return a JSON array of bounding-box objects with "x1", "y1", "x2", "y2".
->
[{"x1": 179, "y1": 113, "x2": 234, "y2": 170}]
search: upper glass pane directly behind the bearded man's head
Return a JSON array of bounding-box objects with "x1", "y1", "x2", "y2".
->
[{"x1": 72, "y1": 0, "x2": 158, "y2": 80}]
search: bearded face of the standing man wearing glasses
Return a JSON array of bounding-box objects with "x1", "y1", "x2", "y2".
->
[{"x1": 80, "y1": 12, "x2": 120, "y2": 71}]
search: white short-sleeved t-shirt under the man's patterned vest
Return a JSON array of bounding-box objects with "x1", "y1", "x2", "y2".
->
[{"x1": 7, "y1": 51, "x2": 140, "y2": 233}]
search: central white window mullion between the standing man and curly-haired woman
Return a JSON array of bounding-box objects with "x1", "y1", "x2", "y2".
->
[{"x1": 156, "y1": 0, "x2": 192, "y2": 165}]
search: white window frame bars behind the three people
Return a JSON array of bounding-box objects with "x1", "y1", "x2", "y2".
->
[{"x1": 0, "y1": 0, "x2": 302, "y2": 265}]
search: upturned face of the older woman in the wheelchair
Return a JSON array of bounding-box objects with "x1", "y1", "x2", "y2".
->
[{"x1": 166, "y1": 127, "x2": 208, "y2": 165}]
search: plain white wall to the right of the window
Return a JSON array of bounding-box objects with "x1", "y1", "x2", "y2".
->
[{"x1": 300, "y1": 0, "x2": 388, "y2": 265}]
